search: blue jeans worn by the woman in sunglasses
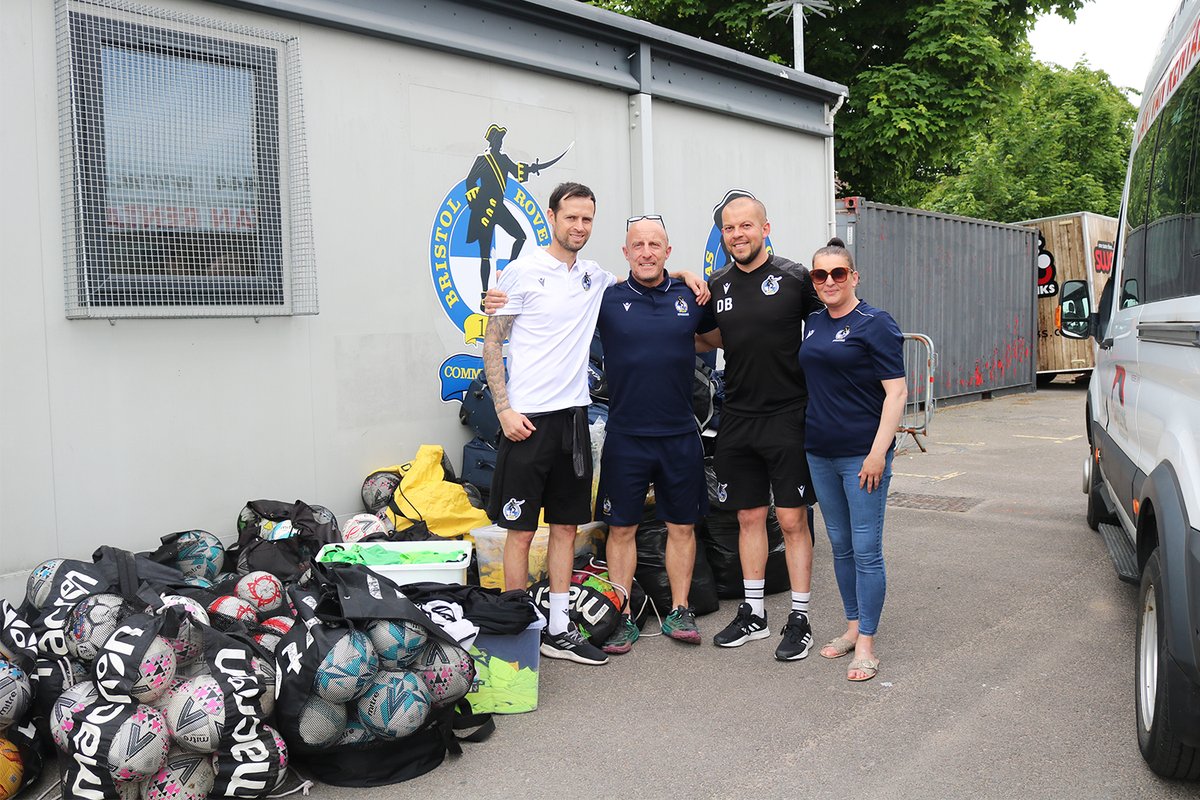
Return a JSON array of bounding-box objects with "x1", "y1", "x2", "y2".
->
[{"x1": 809, "y1": 452, "x2": 892, "y2": 636}]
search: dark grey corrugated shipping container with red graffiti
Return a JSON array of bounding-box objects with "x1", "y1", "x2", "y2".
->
[{"x1": 838, "y1": 198, "x2": 1037, "y2": 399}]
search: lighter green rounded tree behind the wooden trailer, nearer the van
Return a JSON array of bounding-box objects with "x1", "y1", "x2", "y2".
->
[{"x1": 918, "y1": 61, "x2": 1136, "y2": 221}]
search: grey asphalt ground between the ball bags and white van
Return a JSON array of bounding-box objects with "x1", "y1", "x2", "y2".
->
[{"x1": 32, "y1": 380, "x2": 1200, "y2": 800}]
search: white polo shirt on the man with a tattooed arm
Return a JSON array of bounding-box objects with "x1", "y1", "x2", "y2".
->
[{"x1": 497, "y1": 247, "x2": 618, "y2": 414}]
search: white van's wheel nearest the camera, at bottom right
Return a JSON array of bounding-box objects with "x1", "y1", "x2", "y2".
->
[{"x1": 1134, "y1": 548, "x2": 1200, "y2": 780}]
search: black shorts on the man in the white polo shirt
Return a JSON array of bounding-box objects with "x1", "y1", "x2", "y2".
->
[{"x1": 487, "y1": 409, "x2": 592, "y2": 530}]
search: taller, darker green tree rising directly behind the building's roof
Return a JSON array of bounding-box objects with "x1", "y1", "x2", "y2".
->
[{"x1": 592, "y1": 0, "x2": 1086, "y2": 205}]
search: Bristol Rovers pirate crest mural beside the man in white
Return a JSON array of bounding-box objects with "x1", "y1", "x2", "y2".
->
[{"x1": 430, "y1": 124, "x2": 575, "y2": 402}]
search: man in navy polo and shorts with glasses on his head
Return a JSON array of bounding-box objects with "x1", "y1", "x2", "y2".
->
[{"x1": 596, "y1": 215, "x2": 712, "y2": 655}]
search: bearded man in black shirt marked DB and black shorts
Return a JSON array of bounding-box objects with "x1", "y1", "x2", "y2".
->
[{"x1": 698, "y1": 192, "x2": 821, "y2": 661}]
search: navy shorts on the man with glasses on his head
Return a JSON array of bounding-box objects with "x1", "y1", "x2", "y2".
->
[{"x1": 596, "y1": 432, "x2": 708, "y2": 525}]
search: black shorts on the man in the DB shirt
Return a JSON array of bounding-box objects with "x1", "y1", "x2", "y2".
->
[{"x1": 713, "y1": 409, "x2": 816, "y2": 509}]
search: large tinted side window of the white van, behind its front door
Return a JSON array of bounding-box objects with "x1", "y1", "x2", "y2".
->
[{"x1": 1141, "y1": 65, "x2": 1200, "y2": 302}]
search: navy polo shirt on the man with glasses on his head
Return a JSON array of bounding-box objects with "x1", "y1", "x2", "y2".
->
[{"x1": 596, "y1": 275, "x2": 703, "y2": 437}]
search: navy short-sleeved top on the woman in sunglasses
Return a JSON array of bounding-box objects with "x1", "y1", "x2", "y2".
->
[{"x1": 800, "y1": 301, "x2": 904, "y2": 458}]
